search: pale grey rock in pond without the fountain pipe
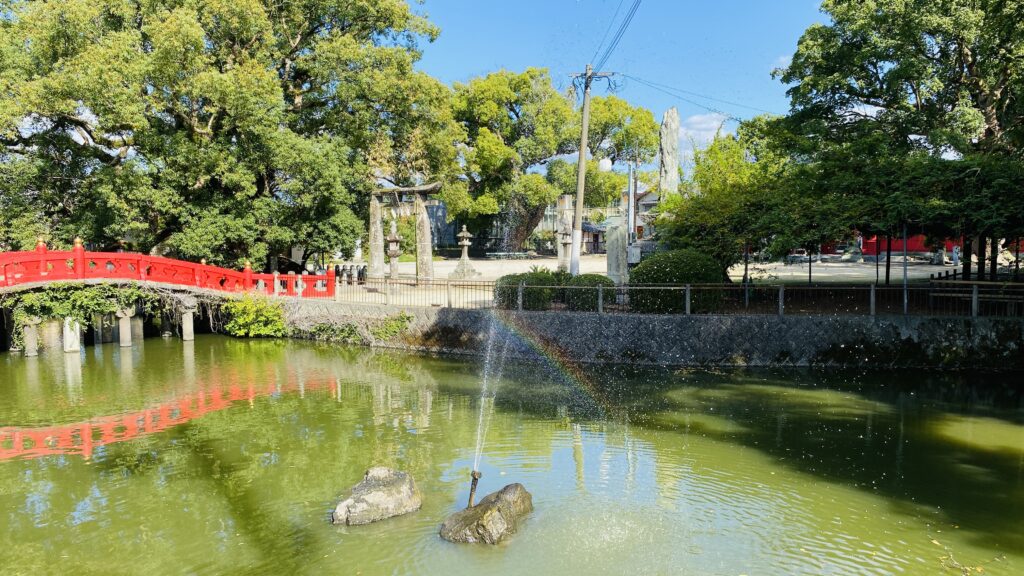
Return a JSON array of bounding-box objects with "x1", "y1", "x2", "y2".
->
[{"x1": 334, "y1": 466, "x2": 423, "y2": 526}]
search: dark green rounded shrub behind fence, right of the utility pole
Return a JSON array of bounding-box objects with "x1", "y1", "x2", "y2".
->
[{"x1": 630, "y1": 249, "x2": 722, "y2": 314}]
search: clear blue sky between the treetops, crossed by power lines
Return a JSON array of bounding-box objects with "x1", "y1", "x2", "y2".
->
[{"x1": 414, "y1": 0, "x2": 824, "y2": 154}]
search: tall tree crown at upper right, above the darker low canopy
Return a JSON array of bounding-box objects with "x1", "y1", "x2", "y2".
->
[{"x1": 777, "y1": 0, "x2": 1024, "y2": 154}]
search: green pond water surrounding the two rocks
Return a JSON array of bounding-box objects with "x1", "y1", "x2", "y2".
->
[{"x1": 0, "y1": 336, "x2": 1024, "y2": 576}]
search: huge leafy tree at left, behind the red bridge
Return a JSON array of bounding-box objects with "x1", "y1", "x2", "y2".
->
[{"x1": 0, "y1": 0, "x2": 448, "y2": 265}]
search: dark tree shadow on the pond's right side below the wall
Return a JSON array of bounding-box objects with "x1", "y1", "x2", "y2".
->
[{"x1": 585, "y1": 364, "x2": 1024, "y2": 551}]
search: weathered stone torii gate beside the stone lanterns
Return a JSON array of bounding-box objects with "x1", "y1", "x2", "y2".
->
[{"x1": 367, "y1": 182, "x2": 441, "y2": 280}]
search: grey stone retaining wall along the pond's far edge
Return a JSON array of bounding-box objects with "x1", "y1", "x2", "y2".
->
[{"x1": 285, "y1": 300, "x2": 1024, "y2": 370}]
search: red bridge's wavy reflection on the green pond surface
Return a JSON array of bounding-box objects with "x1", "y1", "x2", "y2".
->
[{"x1": 0, "y1": 366, "x2": 340, "y2": 460}]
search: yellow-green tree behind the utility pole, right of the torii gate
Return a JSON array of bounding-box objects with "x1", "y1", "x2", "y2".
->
[{"x1": 441, "y1": 68, "x2": 658, "y2": 249}]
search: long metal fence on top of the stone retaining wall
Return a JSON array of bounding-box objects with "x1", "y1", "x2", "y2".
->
[{"x1": 335, "y1": 278, "x2": 1024, "y2": 318}]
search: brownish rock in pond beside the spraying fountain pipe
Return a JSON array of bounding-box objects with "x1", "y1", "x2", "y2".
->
[{"x1": 440, "y1": 484, "x2": 534, "y2": 544}]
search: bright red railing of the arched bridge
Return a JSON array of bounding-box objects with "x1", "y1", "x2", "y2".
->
[{"x1": 0, "y1": 241, "x2": 335, "y2": 298}]
